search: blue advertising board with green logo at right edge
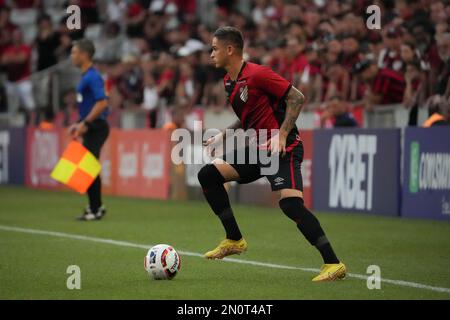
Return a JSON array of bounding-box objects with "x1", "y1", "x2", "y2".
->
[{"x1": 402, "y1": 127, "x2": 450, "y2": 221}]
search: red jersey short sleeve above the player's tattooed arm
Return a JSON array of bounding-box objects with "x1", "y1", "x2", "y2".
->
[{"x1": 253, "y1": 67, "x2": 291, "y2": 99}]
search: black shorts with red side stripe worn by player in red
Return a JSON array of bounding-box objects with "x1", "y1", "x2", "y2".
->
[{"x1": 222, "y1": 136, "x2": 303, "y2": 191}]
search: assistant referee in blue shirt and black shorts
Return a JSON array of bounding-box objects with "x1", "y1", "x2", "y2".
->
[{"x1": 69, "y1": 39, "x2": 109, "y2": 221}]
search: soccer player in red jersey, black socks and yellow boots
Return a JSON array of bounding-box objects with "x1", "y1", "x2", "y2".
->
[{"x1": 198, "y1": 27, "x2": 346, "y2": 281}]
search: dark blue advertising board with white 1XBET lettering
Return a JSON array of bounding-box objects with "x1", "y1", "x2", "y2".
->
[{"x1": 313, "y1": 129, "x2": 400, "y2": 216}]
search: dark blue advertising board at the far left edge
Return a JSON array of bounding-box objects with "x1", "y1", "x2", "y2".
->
[{"x1": 0, "y1": 128, "x2": 26, "y2": 184}]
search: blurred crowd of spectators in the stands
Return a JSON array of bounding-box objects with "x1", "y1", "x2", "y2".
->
[{"x1": 0, "y1": 0, "x2": 450, "y2": 127}]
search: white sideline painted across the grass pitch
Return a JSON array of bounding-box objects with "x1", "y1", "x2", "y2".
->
[{"x1": 0, "y1": 225, "x2": 450, "y2": 293}]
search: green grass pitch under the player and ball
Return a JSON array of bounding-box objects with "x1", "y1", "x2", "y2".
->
[{"x1": 0, "y1": 187, "x2": 450, "y2": 300}]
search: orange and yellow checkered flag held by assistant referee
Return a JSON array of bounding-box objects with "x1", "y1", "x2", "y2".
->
[{"x1": 50, "y1": 141, "x2": 102, "y2": 194}]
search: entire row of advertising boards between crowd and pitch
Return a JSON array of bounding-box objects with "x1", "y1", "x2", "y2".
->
[{"x1": 0, "y1": 127, "x2": 450, "y2": 220}]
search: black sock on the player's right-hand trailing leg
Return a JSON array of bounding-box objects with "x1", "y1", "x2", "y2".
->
[{"x1": 279, "y1": 197, "x2": 339, "y2": 264}]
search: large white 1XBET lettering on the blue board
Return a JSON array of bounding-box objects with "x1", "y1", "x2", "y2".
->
[{"x1": 328, "y1": 134, "x2": 377, "y2": 210}]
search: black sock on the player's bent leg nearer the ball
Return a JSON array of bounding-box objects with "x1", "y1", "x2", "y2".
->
[{"x1": 198, "y1": 164, "x2": 242, "y2": 240}]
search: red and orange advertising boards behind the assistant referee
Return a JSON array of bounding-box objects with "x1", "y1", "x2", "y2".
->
[{"x1": 17, "y1": 127, "x2": 171, "y2": 199}]
